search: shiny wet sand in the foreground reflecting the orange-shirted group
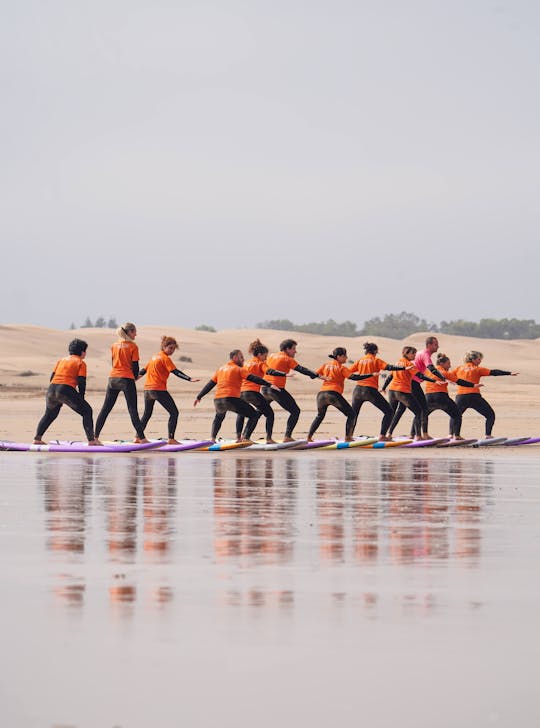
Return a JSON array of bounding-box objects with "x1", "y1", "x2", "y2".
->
[{"x1": 0, "y1": 449, "x2": 540, "y2": 728}]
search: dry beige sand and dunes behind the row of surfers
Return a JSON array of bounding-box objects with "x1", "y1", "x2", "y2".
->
[{"x1": 0, "y1": 324, "x2": 540, "y2": 444}]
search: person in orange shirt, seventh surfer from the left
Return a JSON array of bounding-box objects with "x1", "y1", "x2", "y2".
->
[{"x1": 308, "y1": 346, "x2": 371, "y2": 442}]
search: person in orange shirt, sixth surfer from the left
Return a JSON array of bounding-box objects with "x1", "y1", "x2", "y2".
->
[{"x1": 261, "y1": 339, "x2": 325, "y2": 442}]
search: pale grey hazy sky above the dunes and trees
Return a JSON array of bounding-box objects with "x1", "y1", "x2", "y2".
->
[{"x1": 0, "y1": 0, "x2": 540, "y2": 328}]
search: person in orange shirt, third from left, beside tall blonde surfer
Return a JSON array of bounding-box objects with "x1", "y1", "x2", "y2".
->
[{"x1": 139, "y1": 336, "x2": 199, "y2": 445}]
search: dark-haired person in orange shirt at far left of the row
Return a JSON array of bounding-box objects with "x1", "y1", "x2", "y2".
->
[{"x1": 34, "y1": 339, "x2": 101, "y2": 445}]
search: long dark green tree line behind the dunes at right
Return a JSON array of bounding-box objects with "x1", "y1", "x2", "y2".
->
[{"x1": 256, "y1": 311, "x2": 540, "y2": 339}]
